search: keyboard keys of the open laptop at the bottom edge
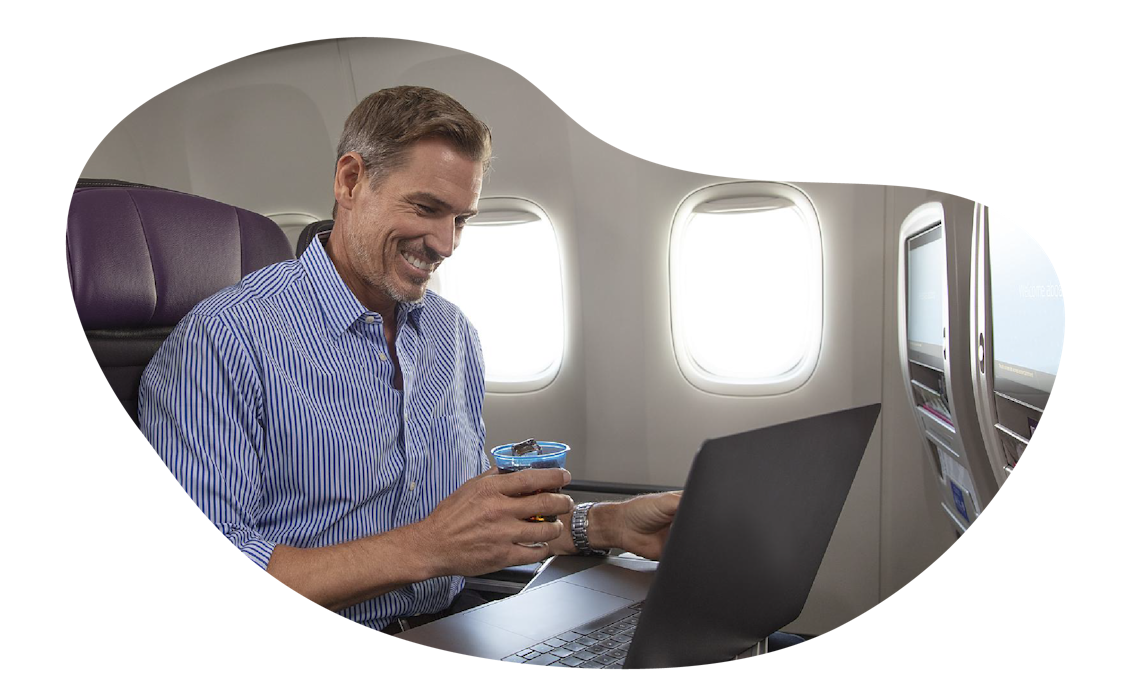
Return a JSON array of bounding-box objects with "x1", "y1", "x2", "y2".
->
[{"x1": 502, "y1": 603, "x2": 642, "y2": 670}]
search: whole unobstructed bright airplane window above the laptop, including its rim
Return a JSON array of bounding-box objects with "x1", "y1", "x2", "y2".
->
[{"x1": 669, "y1": 182, "x2": 823, "y2": 396}]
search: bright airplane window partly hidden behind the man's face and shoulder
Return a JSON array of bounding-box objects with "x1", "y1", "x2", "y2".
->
[{"x1": 439, "y1": 197, "x2": 565, "y2": 392}]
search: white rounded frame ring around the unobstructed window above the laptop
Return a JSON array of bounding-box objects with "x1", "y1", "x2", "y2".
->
[{"x1": 668, "y1": 181, "x2": 824, "y2": 397}]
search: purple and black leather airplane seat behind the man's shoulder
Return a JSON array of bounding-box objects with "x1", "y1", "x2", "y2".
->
[{"x1": 66, "y1": 179, "x2": 292, "y2": 426}]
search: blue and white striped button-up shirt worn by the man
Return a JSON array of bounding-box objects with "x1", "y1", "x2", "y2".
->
[{"x1": 139, "y1": 233, "x2": 489, "y2": 629}]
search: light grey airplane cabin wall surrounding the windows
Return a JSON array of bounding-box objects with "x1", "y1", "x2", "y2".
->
[{"x1": 81, "y1": 38, "x2": 953, "y2": 634}]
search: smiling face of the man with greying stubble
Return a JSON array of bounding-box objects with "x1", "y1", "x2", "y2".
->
[{"x1": 345, "y1": 139, "x2": 483, "y2": 304}]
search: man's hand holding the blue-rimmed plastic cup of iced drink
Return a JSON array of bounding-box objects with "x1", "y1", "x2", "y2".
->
[{"x1": 409, "y1": 469, "x2": 573, "y2": 578}]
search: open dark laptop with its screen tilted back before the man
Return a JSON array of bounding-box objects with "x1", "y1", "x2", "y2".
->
[{"x1": 394, "y1": 404, "x2": 880, "y2": 670}]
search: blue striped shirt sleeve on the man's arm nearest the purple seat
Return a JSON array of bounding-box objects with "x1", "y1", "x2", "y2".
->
[{"x1": 139, "y1": 314, "x2": 276, "y2": 569}]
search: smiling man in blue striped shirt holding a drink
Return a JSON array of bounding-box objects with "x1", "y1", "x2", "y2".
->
[{"x1": 139, "y1": 88, "x2": 679, "y2": 629}]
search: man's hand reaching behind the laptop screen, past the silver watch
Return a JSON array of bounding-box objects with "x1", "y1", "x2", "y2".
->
[{"x1": 587, "y1": 491, "x2": 681, "y2": 560}]
